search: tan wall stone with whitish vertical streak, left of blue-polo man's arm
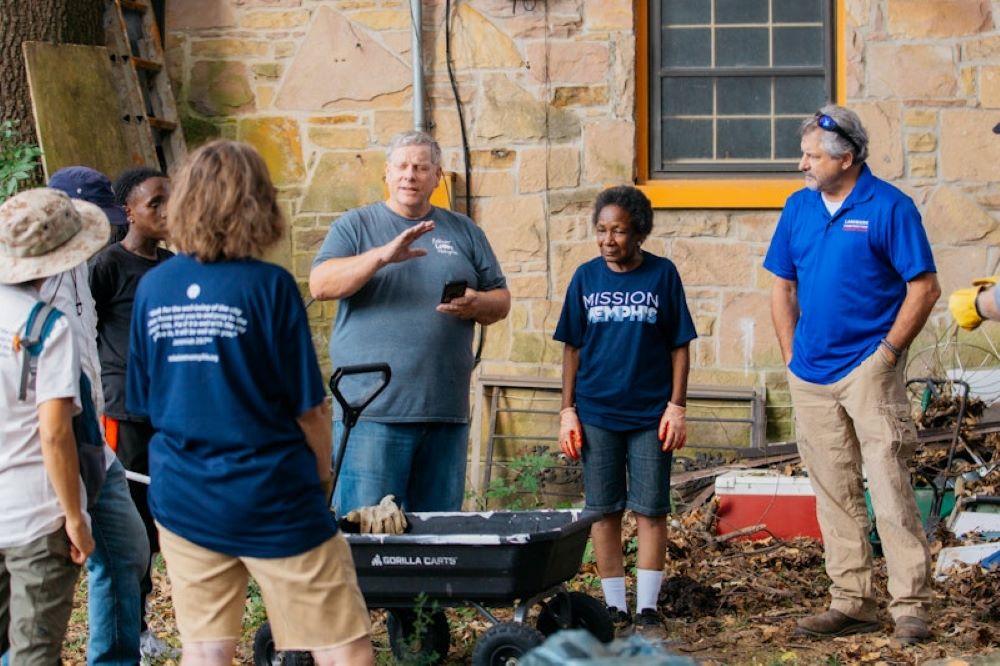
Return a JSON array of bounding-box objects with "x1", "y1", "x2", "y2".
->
[{"x1": 718, "y1": 292, "x2": 781, "y2": 370}]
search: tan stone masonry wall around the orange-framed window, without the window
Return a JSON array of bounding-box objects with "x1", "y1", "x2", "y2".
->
[{"x1": 168, "y1": 0, "x2": 1000, "y2": 446}]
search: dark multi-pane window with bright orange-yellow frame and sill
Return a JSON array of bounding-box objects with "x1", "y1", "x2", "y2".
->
[{"x1": 636, "y1": 0, "x2": 843, "y2": 207}]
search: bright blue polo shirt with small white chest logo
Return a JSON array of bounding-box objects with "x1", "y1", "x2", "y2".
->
[{"x1": 764, "y1": 165, "x2": 936, "y2": 384}]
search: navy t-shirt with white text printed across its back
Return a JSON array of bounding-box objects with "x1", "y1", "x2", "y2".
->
[{"x1": 126, "y1": 255, "x2": 336, "y2": 557}]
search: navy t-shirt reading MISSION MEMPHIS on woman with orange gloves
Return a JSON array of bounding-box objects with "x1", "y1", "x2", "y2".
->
[{"x1": 554, "y1": 251, "x2": 697, "y2": 431}]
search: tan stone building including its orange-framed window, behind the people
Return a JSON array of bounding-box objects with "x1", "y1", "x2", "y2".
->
[{"x1": 166, "y1": 0, "x2": 1000, "y2": 452}]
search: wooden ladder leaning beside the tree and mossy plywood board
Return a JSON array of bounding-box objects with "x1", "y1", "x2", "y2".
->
[{"x1": 104, "y1": 0, "x2": 187, "y2": 173}]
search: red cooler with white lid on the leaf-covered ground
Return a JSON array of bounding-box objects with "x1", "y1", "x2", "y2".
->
[{"x1": 715, "y1": 470, "x2": 822, "y2": 540}]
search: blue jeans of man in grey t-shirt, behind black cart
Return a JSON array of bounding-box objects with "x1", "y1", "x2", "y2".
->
[{"x1": 333, "y1": 421, "x2": 469, "y2": 516}]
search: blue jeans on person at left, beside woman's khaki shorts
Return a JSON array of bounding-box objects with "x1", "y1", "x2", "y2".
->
[{"x1": 87, "y1": 460, "x2": 149, "y2": 665}]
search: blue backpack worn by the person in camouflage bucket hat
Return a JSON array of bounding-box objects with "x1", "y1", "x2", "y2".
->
[{"x1": 17, "y1": 301, "x2": 107, "y2": 509}]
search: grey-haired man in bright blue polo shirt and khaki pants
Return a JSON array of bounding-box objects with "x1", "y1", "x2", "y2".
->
[{"x1": 764, "y1": 105, "x2": 941, "y2": 644}]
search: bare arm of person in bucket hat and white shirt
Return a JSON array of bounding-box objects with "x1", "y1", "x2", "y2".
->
[{"x1": 38, "y1": 398, "x2": 94, "y2": 564}]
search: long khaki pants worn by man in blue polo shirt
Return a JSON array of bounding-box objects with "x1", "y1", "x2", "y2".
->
[{"x1": 788, "y1": 349, "x2": 932, "y2": 620}]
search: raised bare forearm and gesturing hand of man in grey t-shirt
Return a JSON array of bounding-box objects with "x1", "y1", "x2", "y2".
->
[{"x1": 309, "y1": 222, "x2": 434, "y2": 301}]
